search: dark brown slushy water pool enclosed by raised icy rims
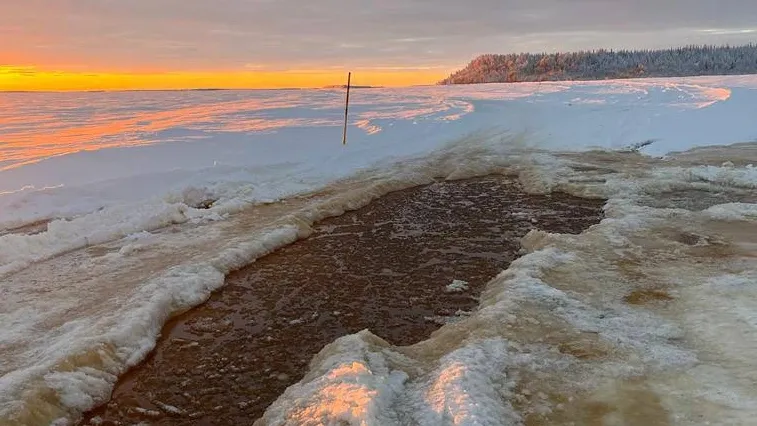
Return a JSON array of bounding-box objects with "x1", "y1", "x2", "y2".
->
[{"x1": 82, "y1": 176, "x2": 603, "y2": 425}]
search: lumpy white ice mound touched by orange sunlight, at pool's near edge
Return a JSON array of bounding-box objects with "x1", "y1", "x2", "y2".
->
[{"x1": 255, "y1": 331, "x2": 520, "y2": 426}]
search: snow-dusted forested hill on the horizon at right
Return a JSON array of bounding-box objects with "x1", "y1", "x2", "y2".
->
[{"x1": 439, "y1": 44, "x2": 757, "y2": 84}]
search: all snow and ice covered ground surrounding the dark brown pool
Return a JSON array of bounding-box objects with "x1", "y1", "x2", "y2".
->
[{"x1": 0, "y1": 77, "x2": 757, "y2": 424}]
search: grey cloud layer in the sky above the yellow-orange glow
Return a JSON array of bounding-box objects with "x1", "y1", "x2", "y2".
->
[{"x1": 0, "y1": 0, "x2": 757, "y2": 68}]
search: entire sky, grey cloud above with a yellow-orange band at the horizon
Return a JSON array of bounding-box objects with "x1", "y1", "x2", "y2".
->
[{"x1": 0, "y1": 0, "x2": 757, "y2": 90}]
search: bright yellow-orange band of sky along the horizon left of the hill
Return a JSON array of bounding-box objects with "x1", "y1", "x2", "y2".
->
[{"x1": 0, "y1": 66, "x2": 447, "y2": 91}]
